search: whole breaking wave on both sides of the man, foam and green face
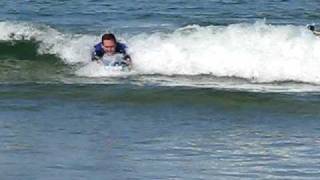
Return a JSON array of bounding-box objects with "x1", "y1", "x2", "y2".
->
[{"x1": 0, "y1": 22, "x2": 320, "y2": 84}]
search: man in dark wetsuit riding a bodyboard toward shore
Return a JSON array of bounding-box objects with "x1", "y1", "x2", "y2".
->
[{"x1": 91, "y1": 33, "x2": 132, "y2": 67}]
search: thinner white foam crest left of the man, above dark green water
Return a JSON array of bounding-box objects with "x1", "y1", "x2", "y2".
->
[{"x1": 0, "y1": 22, "x2": 98, "y2": 64}]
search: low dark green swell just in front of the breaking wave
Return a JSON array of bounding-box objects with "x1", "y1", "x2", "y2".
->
[{"x1": 0, "y1": 83, "x2": 320, "y2": 117}]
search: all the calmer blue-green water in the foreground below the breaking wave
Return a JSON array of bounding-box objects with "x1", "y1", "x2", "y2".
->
[{"x1": 0, "y1": 85, "x2": 320, "y2": 179}]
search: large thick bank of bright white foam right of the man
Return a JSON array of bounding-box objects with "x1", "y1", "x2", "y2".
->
[{"x1": 130, "y1": 23, "x2": 320, "y2": 83}]
